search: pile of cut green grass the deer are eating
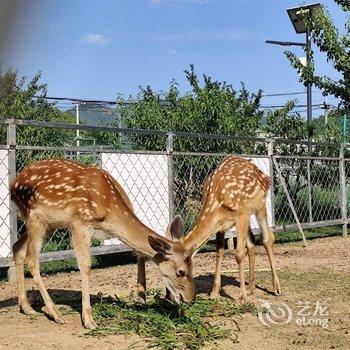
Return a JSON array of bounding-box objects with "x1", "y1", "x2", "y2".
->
[{"x1": 90, "y1": 294, "x2": 256, "y2": 350}]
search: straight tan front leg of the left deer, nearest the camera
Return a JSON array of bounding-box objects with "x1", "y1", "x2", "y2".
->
[{"x1": 72, "y1": 225, "x2": 97, "y2": 329}]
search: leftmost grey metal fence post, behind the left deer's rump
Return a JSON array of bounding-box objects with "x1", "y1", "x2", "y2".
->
[{"x1": 7, "y1": 119, "x2": 17, "y2": 282}]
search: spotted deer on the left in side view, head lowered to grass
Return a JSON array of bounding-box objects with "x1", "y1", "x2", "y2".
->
[{"x1": 11, "y1": 159, "x2": 195, "y2": 329}]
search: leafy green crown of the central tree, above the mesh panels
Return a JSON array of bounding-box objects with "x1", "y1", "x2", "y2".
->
[{"x1": 119, "y1": 65, "x2": 263, "y2": 152}]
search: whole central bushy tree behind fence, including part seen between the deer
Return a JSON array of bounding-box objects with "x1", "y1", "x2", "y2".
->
[{"x1": 120, "y1": 65, "x2": 263, "y2": 227}]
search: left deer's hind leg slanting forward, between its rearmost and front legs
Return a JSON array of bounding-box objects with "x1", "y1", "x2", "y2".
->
[{"x1": 27, "y1": 216, "x2": 67, "y2": 324}]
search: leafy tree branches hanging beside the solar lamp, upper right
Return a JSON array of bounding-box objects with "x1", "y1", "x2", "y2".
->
[{"x1": 285, "y1": 0, "x2": 350, "y2": 111}]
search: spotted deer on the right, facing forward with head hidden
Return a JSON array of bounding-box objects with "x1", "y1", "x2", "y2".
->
[{"x1": 182, "y1": 156, "x2": 281, "y2": 301}]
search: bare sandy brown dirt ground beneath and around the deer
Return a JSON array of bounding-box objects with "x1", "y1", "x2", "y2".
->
[{"x1": 0, "y1": 237, "x2": 350, "y2": 350}]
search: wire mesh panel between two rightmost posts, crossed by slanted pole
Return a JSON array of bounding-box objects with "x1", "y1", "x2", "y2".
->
[{"x1": 274, "y1": 158, "x2": 341, "y2": 225}]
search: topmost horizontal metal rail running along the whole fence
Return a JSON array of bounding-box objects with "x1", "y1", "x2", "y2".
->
[{"x1": 0, "y1": 119, "x2": 341, "y2": 147}]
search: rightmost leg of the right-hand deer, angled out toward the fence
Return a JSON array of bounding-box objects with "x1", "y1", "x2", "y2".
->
[{"x1": 256, "y1": 203, "x2": 281, "y2": 295}]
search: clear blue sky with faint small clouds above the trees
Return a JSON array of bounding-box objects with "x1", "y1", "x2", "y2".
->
[{"x1": 0, "y1": 0, "x2": 345, "y2": 115}]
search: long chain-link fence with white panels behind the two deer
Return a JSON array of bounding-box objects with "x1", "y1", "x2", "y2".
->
[{"x1": 0, "y1": 120, "x2": 350, "y2": 267}]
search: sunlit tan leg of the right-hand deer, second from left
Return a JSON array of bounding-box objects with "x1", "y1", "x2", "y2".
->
[{"x1": 235, "y1": 213, "x2": 249, "y2": 302}]
